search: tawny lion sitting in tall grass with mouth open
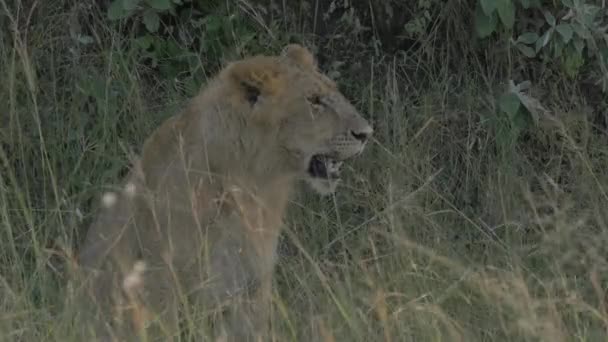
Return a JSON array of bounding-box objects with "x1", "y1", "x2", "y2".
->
[{"x1": 79, "y1": 44, "x2": 372, "y2": 341}]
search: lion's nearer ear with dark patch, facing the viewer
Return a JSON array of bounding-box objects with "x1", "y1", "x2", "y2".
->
[{"x1": 225, "y1": 56, "x2": 284, "y2": 104}]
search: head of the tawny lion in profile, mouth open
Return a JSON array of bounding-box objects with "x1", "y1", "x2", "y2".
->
[{"x1": 217, "y1": 44, "x2": 373, "y2": 195}]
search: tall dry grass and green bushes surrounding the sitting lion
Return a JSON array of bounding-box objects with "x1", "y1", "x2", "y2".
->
[{"x1": 0, "y1": 0, "x2": 608, "y2": 342}]
